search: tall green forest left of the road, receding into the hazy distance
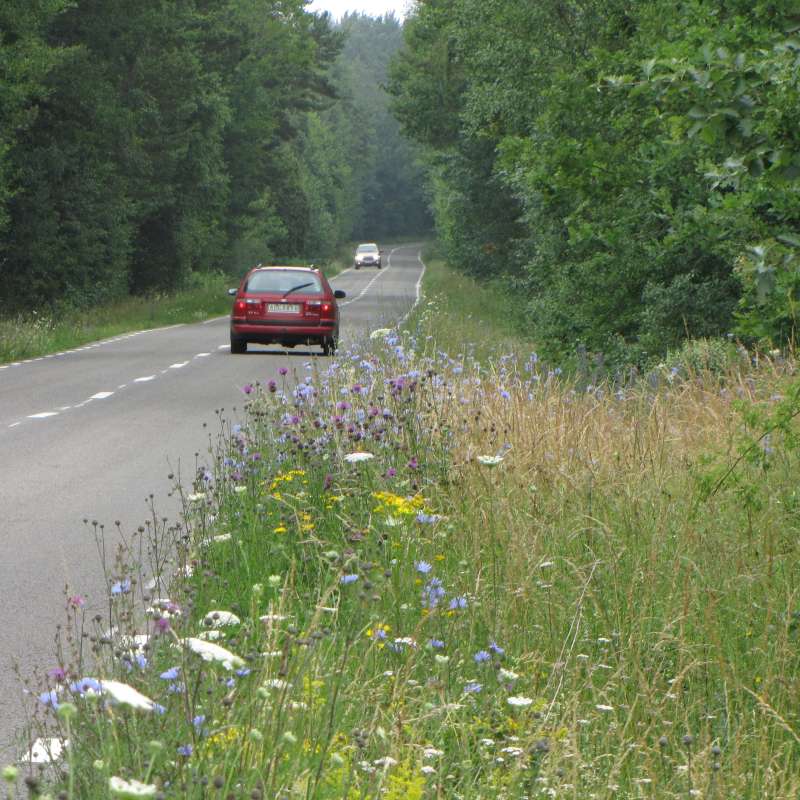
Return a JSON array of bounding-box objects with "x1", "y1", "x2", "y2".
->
[{"x1": 0, "y1": 0, "x2": 426, "y2": 313}]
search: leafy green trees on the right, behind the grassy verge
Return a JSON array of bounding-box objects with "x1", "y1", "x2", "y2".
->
[{"x1": 390, "y1": 0, "x2": 800, "y2": 361}]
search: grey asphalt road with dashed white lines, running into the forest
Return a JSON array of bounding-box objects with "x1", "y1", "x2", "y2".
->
[{"x1": 0, "y1": 245, "x2": 423, "y2": 756}]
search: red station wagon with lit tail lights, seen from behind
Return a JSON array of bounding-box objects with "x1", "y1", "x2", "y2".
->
[{"x1": 228, "y1": 266, "x2": 345, "y2": 356}]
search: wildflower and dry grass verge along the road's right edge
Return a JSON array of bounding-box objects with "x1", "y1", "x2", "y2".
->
[{"x1": 10, "y1": 263, "x2": 800, "y2": 800}]
